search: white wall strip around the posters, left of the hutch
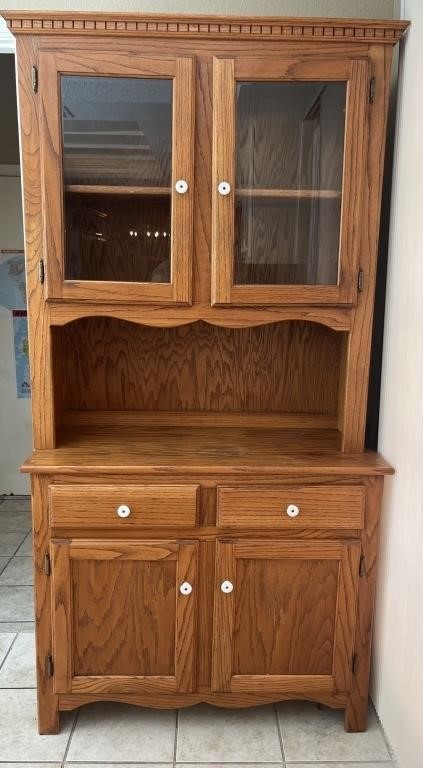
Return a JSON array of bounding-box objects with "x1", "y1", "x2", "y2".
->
[{"x1": 0, "y1": 176, "x2": 31, "y2": 494}]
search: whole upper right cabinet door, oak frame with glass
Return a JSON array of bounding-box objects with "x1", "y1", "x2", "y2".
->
[{"x1": 212, "y1": 58, "x2": 368, "y2": 304}]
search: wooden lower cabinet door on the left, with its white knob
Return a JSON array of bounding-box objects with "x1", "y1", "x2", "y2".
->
[{"x1": 51, "y1": 539, "x2": 198, "y2": 693}]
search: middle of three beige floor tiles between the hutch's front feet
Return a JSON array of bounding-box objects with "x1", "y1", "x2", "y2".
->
[{"x1": 176, "y1": 704, "x2": 282, "y2": 763}]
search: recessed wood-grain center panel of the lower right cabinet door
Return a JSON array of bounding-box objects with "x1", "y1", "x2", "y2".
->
[{"x1": 233, "y1": 559, "x2": 339, "y2": 675}]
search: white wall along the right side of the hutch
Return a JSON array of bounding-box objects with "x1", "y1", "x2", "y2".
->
[{"x1": 372, "y1": 0, "x2": 423, "y2": 768}]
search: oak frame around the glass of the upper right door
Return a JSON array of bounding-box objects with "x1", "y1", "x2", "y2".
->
[{"x1": 212, "y1": 52, "x2": 370, "y2": 306}]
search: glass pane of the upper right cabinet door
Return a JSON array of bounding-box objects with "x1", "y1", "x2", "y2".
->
[{"x1": 234, "y1": 82, "x2": 346, "y2": 285}]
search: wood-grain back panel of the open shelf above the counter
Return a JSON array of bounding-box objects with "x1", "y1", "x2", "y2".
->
[{"x1": 56, "y1": 317, "x2": 342, "y2": 414}]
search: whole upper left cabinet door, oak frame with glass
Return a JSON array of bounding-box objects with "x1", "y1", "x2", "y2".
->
[{"x1": 40, "y1": 50, "x2": 194, "y2": 303}]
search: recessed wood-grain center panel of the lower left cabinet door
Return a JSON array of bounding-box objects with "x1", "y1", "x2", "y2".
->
[{"x1": 72, "y1": 553, "x2": 176, "y2": 676}]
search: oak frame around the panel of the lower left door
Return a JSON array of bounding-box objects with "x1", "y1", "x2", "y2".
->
[{"x1": 50, "y1": 539, "x2": 199, "y2": 694}]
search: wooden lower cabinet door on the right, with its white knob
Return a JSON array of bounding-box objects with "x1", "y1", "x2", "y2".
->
[{"x1": 212, "y1": 539, "x2": 360, "y2": 696}]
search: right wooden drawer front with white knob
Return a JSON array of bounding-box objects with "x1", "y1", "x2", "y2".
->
[{"x1": 217, "y1": 485, "x2": 365, "y2": 529}]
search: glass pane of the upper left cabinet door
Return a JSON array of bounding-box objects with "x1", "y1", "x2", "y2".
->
[{"x1": 61, "y1": 75, "x2": 173, "y2": 283}]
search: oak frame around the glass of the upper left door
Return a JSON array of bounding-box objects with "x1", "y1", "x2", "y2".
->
[{"x1": 39, "y1": 44, "x2": 195, "y2": 304}]
